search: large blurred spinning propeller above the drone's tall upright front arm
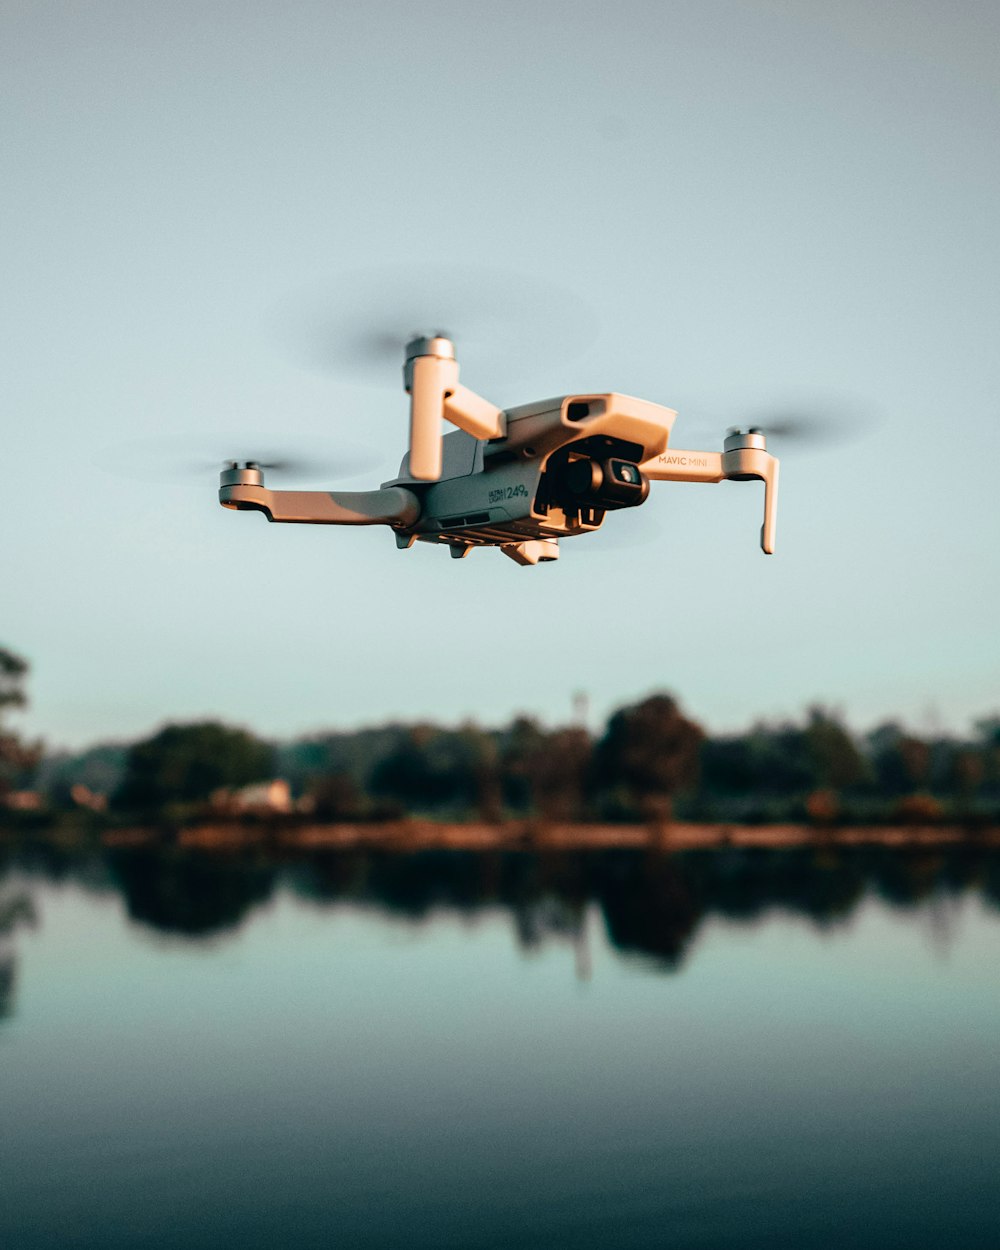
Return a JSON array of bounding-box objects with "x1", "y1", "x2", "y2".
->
[{"x1": 269, "y1": 264, "x2": 598, "y2": 390}]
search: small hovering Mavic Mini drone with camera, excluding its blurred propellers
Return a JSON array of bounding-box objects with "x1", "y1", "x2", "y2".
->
[{"x1": 219, "y1": 334, "x2": 779, "y2": 565}]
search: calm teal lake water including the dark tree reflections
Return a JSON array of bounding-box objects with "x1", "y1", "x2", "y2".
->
[{"x1": 0, "y1": 851, "x2": 1000, "y2": 1250}]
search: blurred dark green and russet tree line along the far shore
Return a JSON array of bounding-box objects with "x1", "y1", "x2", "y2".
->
[{"x1": 0, "y1": 650, "x2": 1000, "y2": 824}]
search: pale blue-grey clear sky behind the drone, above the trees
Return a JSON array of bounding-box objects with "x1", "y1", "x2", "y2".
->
[{"x1": 0, "y1": 0, "x2": 1000, "y2": 746}]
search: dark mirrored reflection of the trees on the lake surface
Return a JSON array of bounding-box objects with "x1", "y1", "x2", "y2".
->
[{"x1": 0, "y1": 843, "x2": 1000, "y2": 995}]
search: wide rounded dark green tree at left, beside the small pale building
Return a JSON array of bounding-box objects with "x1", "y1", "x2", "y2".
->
[{"x1": 115, "y1": 721, "x2": 274, "y2": 811}]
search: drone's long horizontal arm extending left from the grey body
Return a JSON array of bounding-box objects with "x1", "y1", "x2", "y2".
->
[{"x1": 219, "y1": 484, "x2": 420, "y2": 528}]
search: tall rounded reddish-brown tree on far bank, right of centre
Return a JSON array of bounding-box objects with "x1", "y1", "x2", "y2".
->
[{"x1": 596, "y1": 694, "x2": 705, "y2": 819}]
